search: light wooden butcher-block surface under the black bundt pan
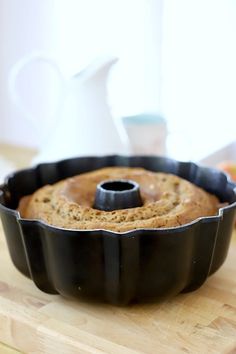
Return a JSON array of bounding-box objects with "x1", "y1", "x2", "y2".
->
[{"x1": 0, "y1": 142, "x2": 236, "y2": 354}]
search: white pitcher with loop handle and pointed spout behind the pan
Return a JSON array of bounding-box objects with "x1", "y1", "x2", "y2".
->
[{"x1": 9, "y1": 53, "x2": 129, "y2": 163}]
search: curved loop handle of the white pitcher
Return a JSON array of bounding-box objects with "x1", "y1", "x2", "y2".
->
[{"x1": 8, "y1": 52, "x2": 66, "y2": 140}]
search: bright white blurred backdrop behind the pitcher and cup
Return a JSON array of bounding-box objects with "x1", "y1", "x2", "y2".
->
[{"x1": 0, "y1": 0, "x2": 236, "y2": 159}]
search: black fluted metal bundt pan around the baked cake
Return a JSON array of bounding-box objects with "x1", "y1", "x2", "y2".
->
[{"x1": 0, "y1": 156, "x2": 236, "y2": 305}]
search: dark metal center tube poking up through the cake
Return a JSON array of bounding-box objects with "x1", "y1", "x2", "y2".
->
[{"x1": 93, "y1": 179, "x2": 143, "y2": 211}]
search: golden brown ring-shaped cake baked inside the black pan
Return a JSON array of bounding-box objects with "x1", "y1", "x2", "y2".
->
[{"x1": 18, "y1": 167, "x2": 219, "y2": 232}]
